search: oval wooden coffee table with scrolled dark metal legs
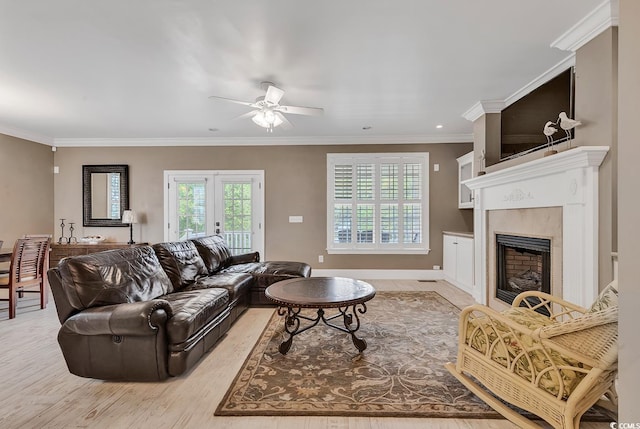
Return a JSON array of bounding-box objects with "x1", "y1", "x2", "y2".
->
[{"x1": 265, "y1": 277, "x2": 376, "y2": 355}]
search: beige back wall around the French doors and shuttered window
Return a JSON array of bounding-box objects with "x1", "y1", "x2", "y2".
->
[{"x1": 54, "y1": 143, "x2": 473, "y2": 269}]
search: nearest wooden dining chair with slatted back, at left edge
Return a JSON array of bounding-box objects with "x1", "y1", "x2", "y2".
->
[{"x1": 0, "y1": 237, "x2": 51, "y2": 319}]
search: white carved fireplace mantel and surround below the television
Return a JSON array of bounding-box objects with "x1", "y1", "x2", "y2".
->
[{"x1": 463, "y1": 146, "x2": 609, "y2": 307}]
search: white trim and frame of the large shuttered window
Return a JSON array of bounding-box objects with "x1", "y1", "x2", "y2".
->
[{"x1": 326, "y1": 152, "x2": 430, "y2": 255}]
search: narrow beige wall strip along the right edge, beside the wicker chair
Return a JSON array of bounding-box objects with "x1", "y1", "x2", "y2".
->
[{"x1": 618, "y1": 0, "x2": 640, "y2": 423}]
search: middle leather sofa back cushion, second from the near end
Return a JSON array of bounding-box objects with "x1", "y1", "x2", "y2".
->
[{"x1": 153, "y1": 241, "x2": 208, "y2": 290}]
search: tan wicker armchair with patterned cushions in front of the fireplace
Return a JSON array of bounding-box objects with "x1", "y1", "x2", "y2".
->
[{"x1": 445, "y1": 282, "x2": 618, "y2": 428}]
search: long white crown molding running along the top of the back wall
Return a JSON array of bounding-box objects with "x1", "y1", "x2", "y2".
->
[{"x1": 54, "y1": 134, "x2": 473, "y2": 147}]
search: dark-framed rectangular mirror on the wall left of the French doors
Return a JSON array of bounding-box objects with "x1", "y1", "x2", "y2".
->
[{"x1": 82, "y1": 165, "x2": 129, "y2": 226}]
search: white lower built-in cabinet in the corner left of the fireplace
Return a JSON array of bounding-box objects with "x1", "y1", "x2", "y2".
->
[{"x1": 442, "y1": 232, "x2": 473, "y2": 294}]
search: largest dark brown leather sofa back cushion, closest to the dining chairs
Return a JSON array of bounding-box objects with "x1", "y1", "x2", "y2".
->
[{"x1": 58, "y1": 246, "x2": 173, "y2": 310}]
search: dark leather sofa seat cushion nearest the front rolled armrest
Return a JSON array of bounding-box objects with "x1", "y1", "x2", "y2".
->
[{"x1": 162, "y1": 288, "x2": 229, "y2": 344}]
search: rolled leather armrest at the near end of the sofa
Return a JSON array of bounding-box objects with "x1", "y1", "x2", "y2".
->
[{"x1": 63, "y1": 299, "x2": 172, "y2": 336}]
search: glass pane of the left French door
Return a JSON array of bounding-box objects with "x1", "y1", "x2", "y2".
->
[{"x1": 177, "y1": 182, "x2": 207, "y2": 240}]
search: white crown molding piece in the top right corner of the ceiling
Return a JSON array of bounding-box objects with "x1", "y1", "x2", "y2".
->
[{"x1": 551, "y1": 0, "x2": 619, "y2": 52}]
